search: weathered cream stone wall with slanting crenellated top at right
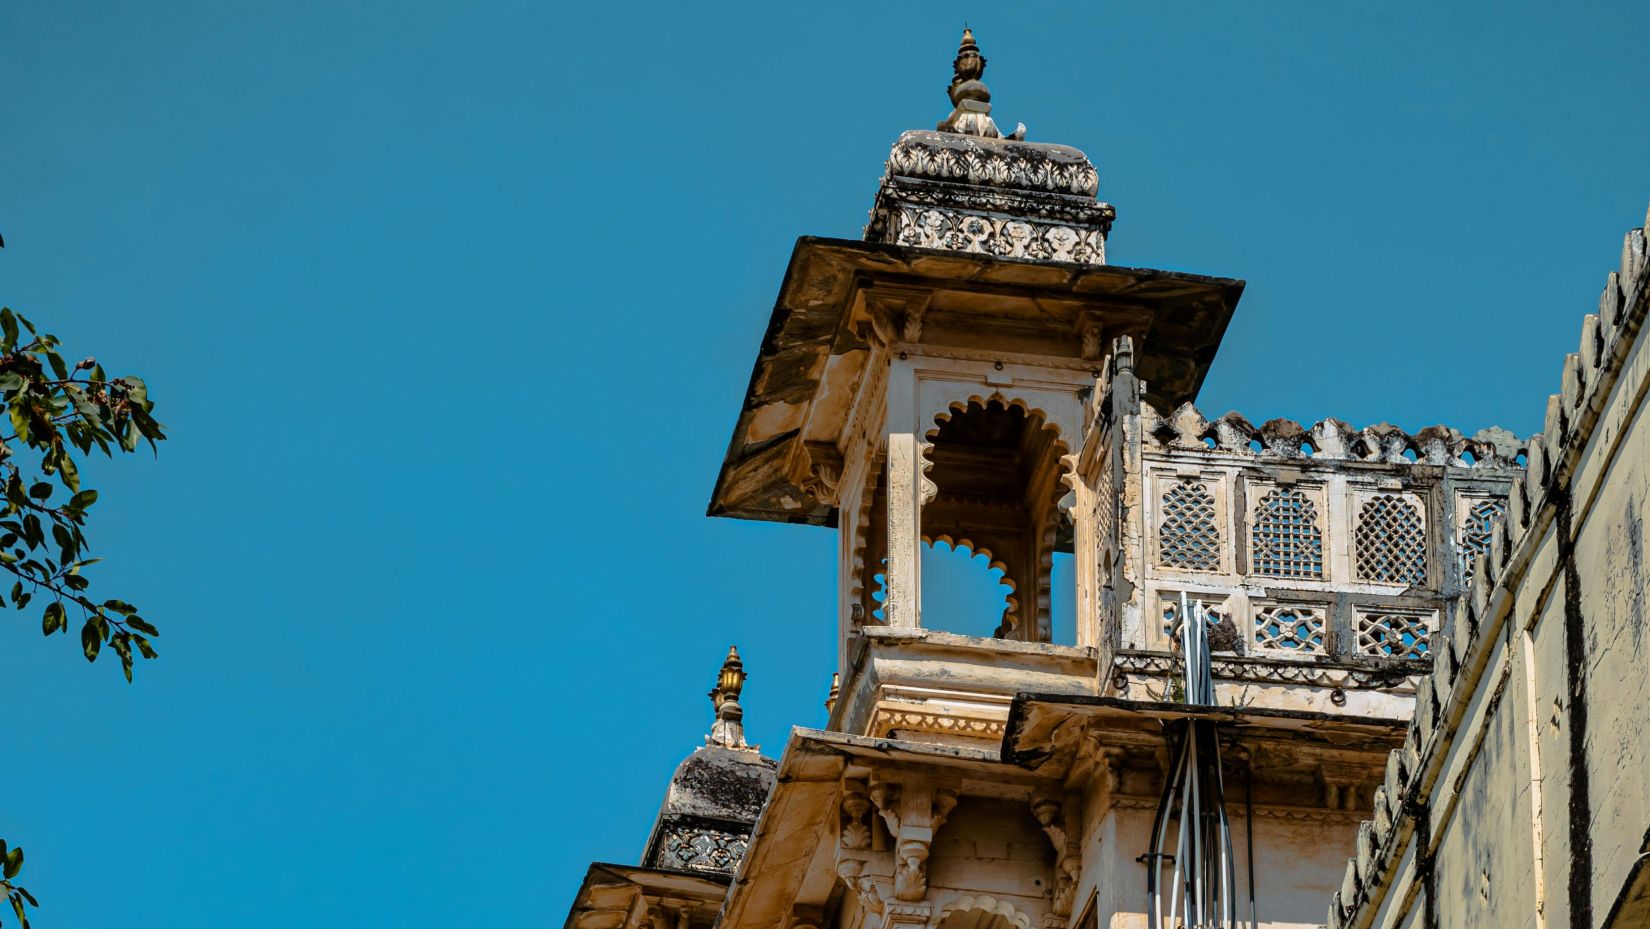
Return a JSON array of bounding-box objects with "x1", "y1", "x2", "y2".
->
[{"x1": 1328, "y1": 212, "x2": 1650, "y2": 929}]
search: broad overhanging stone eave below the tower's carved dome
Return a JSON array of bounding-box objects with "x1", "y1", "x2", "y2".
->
[{"x1": 706, "y1": 236, "x2": 1244, "y2": 526}]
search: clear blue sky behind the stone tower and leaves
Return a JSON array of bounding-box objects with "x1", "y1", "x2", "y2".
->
[{"x1": 0, "y1": 0, "x2": 1650, "y2": 929}]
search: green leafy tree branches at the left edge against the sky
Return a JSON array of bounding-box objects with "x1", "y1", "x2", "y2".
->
[{"x1": 0, "y1": 309, "x2": 167, "y2": 929}]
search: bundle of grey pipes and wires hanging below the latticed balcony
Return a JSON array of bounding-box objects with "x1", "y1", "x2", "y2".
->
[{"x1": 1143, "y1": 594, "x2": 1256, "y2": 929}]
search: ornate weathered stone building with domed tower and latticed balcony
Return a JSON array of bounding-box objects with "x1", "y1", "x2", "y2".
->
[{"x1": 568, "y1": 33, "x2": 1650, "y2": 929}]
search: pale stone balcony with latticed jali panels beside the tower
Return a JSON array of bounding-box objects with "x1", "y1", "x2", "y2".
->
[{"x1": 1086, "y1": 374, "x2": 1525, "y2": 719}]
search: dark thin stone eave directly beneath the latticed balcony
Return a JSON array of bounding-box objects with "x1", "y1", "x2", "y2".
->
[{"x1": 1002, "y1": 693, "x2": 1409, "y2": 769}]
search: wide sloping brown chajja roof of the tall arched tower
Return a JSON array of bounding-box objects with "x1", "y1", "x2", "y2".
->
[{"x1": 708, "y1": 236, "x2": 1244, "y2": 525}]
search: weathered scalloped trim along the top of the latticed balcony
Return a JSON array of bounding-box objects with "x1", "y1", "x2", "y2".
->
[{"x1": 1140, "y1": 403, "x2": 1539, "y2": 470}]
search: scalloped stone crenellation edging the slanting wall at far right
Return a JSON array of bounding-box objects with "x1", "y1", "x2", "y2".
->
[{"x1": 1327, "y1": 218, "x2": 1650, "y2": 929}]
